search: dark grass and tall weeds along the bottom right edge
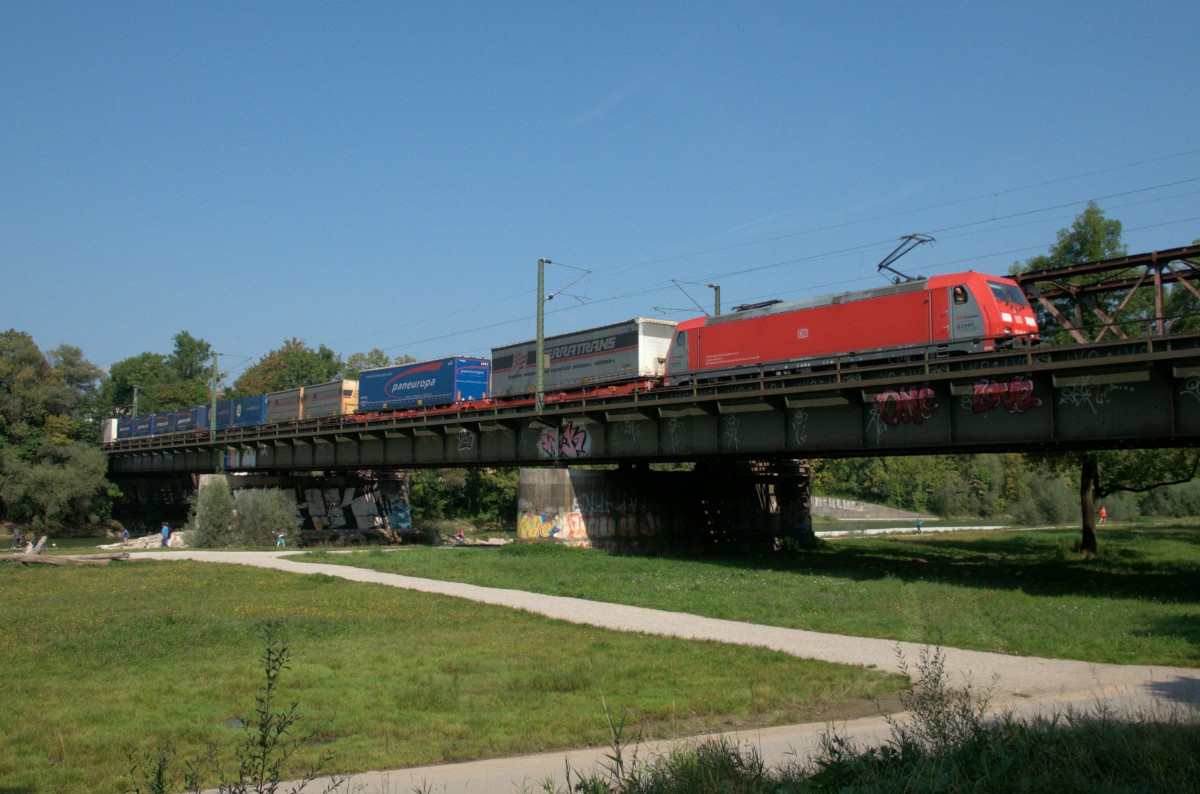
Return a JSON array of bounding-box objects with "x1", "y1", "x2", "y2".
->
[{"x1": 542, "y1": 646, "x2": 1200, "y2": 794}]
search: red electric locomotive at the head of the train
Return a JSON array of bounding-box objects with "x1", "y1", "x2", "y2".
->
[{"x1": 666, "y1": 272, "x2": 1038, "y2": 385}]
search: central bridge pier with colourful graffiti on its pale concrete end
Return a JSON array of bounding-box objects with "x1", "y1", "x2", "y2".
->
[{"x1": 517, "y1": 459, "x2": 815, "y2": 554}]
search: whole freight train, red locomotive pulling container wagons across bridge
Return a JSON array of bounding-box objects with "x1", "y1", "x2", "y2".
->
[{"x1": 104, "y1": 271, "x2": 1038, "y2": 443}]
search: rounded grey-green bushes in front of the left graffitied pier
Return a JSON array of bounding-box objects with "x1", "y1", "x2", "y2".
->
[{"x1": 187, "y1": 476, "x2": 300, "y2": 548}]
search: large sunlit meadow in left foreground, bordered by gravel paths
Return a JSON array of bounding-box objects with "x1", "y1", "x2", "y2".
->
[{"x1": 0, "y1": 563, "x2": 906, "y2": 793}]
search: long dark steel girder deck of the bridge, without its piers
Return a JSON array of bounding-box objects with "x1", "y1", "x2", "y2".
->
[{"x1": 104, "y1": 333, "x2": 1200, "y2": 474}]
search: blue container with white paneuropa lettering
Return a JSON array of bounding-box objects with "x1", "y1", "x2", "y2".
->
[{"x1": 359, "y1": 356, "x2": 492, "y2": 411}]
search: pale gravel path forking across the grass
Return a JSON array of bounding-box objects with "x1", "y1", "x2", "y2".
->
[{"x1": 137, "y1": 549, "x2": 1200, "y2": 794}]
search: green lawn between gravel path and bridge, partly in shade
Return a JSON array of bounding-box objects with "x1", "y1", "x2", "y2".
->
[{"x1": 304, "y1": 527, "x2": 1200, "y2": 667}]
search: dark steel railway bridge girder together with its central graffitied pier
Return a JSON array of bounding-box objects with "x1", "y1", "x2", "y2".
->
[{"x1": 106, "y1": 333, "x2": 1200, "y2": 548}]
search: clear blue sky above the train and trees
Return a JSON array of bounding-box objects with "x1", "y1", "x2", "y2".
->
[{"x1": 0, "y1": 0, "x2": 1200, "y2": 377}]
